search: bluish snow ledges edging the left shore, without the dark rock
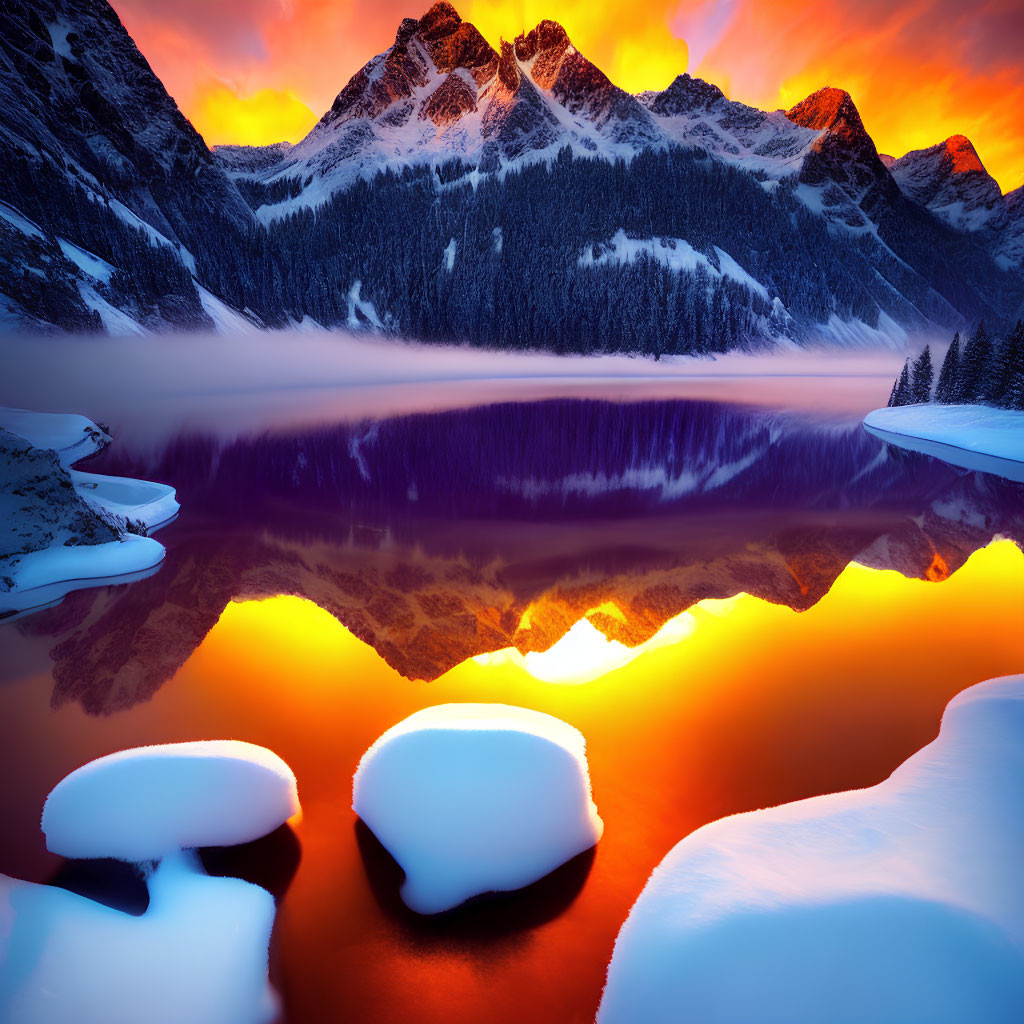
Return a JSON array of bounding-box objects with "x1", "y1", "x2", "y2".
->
[{"x1": 0, "y1": 409, "x2": 179, "y2": 617}]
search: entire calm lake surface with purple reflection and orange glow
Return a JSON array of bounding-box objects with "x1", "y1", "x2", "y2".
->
[{"x1": 0, "y1": 400, "x2": 1024, "y2": 1024}]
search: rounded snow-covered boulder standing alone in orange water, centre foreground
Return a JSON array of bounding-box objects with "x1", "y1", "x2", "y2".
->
[{"x1": 352, "y1": 703, "x2": 603, "y2": 913}]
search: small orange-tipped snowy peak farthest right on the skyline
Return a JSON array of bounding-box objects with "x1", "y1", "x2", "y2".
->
[{"x1": 892, "y1": 135, "x2": 1007, "y2": 230}]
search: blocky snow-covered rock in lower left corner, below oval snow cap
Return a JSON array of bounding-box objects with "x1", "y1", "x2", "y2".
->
[{"x1": 0, "y1": 854, "x2": 278, "y2": 1024}]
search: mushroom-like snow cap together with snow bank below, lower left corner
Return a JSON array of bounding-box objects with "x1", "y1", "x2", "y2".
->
[{"x1": 0, "y1": 740, "x2": 299, "y2": 1024}]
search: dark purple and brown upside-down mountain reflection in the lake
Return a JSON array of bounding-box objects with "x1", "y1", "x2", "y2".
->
[{"x1": 7, "y1": 400, "x2": 1024, "y2": 715}]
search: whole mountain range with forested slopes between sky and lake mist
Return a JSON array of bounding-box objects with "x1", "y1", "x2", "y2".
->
[{"x1": 0, "y1": 0, "x2": 1024, "y2": 355}]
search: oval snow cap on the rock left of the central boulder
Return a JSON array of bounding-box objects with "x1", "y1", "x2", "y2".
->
[{"x1": 42, "y1": 739, "x2": 299, "y2": 861}]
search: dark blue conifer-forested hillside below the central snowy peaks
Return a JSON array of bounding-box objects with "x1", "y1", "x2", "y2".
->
[{"x1": 228, "y1": 147, "x2": 1014, "y2": 353}]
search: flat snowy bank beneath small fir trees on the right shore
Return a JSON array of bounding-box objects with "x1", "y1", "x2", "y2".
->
[{"x1": 864, "y1": 403, "x2": 1024, "y2": 482}]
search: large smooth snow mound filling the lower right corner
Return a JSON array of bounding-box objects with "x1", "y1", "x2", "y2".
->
[{"x1": 598, "y1": 676, "x2": 1024, "y2": 1024}]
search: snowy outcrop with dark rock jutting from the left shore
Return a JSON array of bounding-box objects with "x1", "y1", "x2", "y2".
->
[{"x1": 0, "y1": 408, "x2": 178, "y2": 615}]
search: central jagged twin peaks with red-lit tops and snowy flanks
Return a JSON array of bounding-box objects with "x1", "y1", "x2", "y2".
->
[{"x1": 216, "y1": 0, "x2": 665, "y2": 221}]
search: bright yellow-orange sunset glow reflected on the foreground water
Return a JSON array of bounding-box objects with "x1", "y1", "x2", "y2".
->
[{"x1": 0, "y1": 524, "x2": 1024, "y2": 1024}]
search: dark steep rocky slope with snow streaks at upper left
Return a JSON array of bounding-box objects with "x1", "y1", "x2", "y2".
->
[{"x1": 0, "y1": 0, "x2": 254, "y2": 330}]
